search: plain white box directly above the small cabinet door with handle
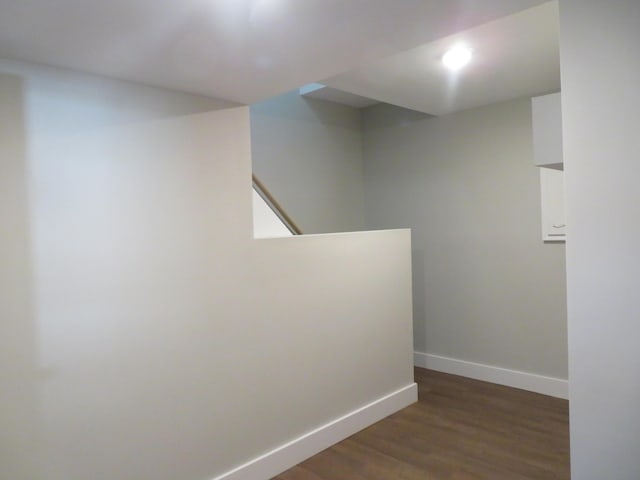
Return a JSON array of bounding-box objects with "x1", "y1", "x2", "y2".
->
[{"x1": 531, "y1": 93, "x2": 562, "y2": 169}]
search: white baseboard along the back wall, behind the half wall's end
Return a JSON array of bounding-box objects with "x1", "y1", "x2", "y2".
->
[{"x1": 413, "y1": 352, "x2": 569, "y2": 398}]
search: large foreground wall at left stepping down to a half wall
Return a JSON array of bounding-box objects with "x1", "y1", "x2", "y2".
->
[{"x1": 0, "y1": 62, "x2": 413, "y2": 480}]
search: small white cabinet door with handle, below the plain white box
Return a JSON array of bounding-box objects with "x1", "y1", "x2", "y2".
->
[{"x1": 540, "y1": 168, "x2": 567, "y2": 242}]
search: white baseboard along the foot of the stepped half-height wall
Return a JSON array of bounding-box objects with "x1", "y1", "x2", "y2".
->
[{"x1": 213, "y1": 383, "x2": 418, "y2": 480}]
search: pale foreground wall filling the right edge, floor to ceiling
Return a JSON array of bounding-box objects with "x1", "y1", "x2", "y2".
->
[{"x1": 560, "y1": 0, "x2": 640, "y2": 480}]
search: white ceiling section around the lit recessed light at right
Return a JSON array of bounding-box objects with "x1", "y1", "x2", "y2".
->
[{"x1": 322, "y1": 2, "x2": 560, "y2": 115}]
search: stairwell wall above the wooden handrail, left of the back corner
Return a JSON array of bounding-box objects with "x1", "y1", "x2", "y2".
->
[{"x1": 251, "y1": 91, "x2": 364, "y2": 233}]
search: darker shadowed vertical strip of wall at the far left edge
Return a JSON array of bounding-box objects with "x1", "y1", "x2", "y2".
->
[{"x1": 0, "y1": 74, "x2": 46, "y2": 479}]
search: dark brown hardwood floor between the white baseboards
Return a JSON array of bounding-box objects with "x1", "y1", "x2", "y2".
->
[{"x1": 274, "y1": 368, "x2": 569, "y2": 480}]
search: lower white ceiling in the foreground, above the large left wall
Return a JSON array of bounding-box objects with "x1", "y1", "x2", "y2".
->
[{"x1": 0, "y1": 0, "x2": 544, "y2": 108}]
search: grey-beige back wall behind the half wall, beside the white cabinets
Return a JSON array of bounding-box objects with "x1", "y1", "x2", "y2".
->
[{"x1": 364, "y1": 99, "x2": 567, "y2": 379}]
